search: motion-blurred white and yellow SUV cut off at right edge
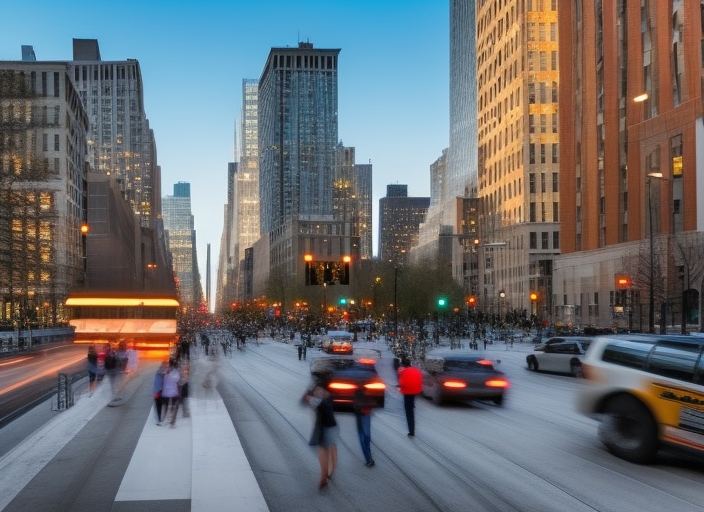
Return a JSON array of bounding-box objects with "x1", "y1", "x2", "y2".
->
[{"x1": 577, "y1": 334, "x2": 704, "y2": 464}]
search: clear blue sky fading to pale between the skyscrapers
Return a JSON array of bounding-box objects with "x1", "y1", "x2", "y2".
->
[{"x1": 0, "y1": 0, "x2": 450, "y2": 298}]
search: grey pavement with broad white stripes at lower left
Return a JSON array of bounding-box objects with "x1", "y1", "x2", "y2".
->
[{"x1": 0, "y1": 352, "x2": 268, "y2": 512}]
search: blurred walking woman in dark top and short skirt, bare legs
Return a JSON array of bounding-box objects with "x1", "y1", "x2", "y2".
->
[{"x1": 303, "y1": 376, "x2": 339, "y2": 490}]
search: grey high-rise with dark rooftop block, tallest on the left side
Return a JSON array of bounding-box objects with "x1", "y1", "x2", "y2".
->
[{"x1": 70, "y1": 39, "x2": 161, "y2": 228}]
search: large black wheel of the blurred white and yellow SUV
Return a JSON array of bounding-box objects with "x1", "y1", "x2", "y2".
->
[{"x1": 599, "y1": 395, "x2": 659, "y2": 464}]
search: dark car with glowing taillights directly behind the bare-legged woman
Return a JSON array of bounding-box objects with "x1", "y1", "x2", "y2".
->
[{"x1": 310, "y1": 354, "x2": 386, "y2": 409}]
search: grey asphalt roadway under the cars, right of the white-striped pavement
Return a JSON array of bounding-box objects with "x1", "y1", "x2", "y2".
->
[{"x1": 214, "y1": 342, "x2": 704, "y2": 512}]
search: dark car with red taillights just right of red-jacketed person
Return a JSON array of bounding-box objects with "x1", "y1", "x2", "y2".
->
[{"x1": 420, "y1": 349, "x2": 510, "y2": 405}]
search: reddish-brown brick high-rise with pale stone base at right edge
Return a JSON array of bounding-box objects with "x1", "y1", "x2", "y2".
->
[{"x1": 555, "y1": 0, "x2": 704, "y2": 331}]
